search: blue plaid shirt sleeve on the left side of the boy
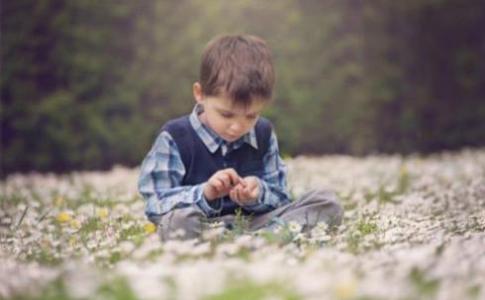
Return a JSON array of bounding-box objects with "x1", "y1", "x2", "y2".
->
[{"x1": 138, "y1": 131, "x2": 220, "y2": 221}]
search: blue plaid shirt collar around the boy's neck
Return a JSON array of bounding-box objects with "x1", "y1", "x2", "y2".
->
[{"x1": 189, "y1": 104, "x2": 258, "y2": 153}]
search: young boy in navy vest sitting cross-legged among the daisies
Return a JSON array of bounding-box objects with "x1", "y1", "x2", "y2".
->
[{"x1": 138, "y1": 35, "x2": 342, "y2": 240}]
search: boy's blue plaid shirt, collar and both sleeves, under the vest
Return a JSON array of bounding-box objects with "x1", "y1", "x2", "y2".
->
[{"x1": 138, "y1": 105, "x2": 289, "y2": 219}]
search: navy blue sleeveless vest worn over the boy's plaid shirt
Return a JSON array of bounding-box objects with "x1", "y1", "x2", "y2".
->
[{"x1": 162, "y1": 116, "x2": 272, "y2": 215}]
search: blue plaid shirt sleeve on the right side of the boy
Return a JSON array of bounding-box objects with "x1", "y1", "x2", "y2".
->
[{"x1": 245, "y1": 131, "x2": 290, "y2": 213}]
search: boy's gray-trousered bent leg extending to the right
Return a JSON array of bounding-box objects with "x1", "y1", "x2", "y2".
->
[{"x1": 251, "y1": 190, "x2": 343, "y2": 230}]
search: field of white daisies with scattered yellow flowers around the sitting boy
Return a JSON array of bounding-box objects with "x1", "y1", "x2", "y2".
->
[{"x1": 0, "y1": 149, "x2": 485, "y2": 299}]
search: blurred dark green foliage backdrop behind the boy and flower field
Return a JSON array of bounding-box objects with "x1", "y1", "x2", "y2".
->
[{"x1": 0, "y1": 0, "x2": 485, "y2": 176}]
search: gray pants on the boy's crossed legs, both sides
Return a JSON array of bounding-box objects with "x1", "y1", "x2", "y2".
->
[{"x1": 158, "y1": 190, "x2": 343, "y2": 241}]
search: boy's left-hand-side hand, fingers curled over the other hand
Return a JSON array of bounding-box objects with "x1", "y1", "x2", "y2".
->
[{"x1": 203, "y1": 168, "x2": 245, "y2": 201}]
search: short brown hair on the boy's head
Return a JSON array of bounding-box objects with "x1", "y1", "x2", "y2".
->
[{"x1": 199, "y1": 35, "x2": 275, "y2": 105}]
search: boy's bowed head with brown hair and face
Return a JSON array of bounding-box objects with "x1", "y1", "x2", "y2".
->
[{"x1": 193, "y1": 35, "x2": 275, "y2": 141}]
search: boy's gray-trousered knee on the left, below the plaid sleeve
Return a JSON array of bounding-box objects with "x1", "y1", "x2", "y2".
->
[{"x1": 158, "y1": 207, "x2": 204, "y2": 241}]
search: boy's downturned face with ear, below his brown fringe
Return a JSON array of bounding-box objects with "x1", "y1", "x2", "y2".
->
[{"x1": 194, "y1": 83, "x2": 266, "y2": 142}]
